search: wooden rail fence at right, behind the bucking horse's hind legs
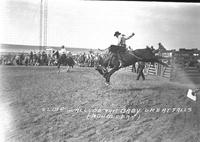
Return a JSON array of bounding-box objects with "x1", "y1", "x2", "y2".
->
[{"x1": 126, "y1": 48, "x2": 200, "y2": 80}]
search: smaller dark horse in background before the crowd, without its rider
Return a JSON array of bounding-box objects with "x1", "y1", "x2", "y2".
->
[{"x1": 53, "y1": 51, "x2": 75, "y2": 72}]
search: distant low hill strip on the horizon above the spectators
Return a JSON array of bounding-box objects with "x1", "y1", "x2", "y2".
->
[{"x1": 0, "y1": 44, "x2": 97, "y2": 54}]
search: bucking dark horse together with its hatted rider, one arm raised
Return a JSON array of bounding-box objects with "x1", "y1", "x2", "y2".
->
[{"x1": 96, "y1": 31, "x2": 168, "y2": 85}]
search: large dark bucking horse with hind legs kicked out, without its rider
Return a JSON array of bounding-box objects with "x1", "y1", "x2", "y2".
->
[{"x1": 96, "y1": 45, "x2": 167, "y2": 85}]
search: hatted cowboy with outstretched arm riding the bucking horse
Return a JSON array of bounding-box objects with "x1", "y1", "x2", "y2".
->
[{"x1": 114, "y1": 31, "x2": 135, "y2": 67}]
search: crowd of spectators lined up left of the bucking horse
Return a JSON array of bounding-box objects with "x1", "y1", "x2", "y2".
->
[{"x1": 0, "y1": 50, "x2": 100, "y2": 67}]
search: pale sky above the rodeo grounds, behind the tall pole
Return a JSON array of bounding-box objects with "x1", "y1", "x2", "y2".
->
[{"x1": 0, "y1": 0, "x2": 200, "y2": 50}]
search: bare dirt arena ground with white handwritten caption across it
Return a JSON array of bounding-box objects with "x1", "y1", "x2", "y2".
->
[{"x1": 0, "y1": 66, "x2": 200, "y2": 142}]
